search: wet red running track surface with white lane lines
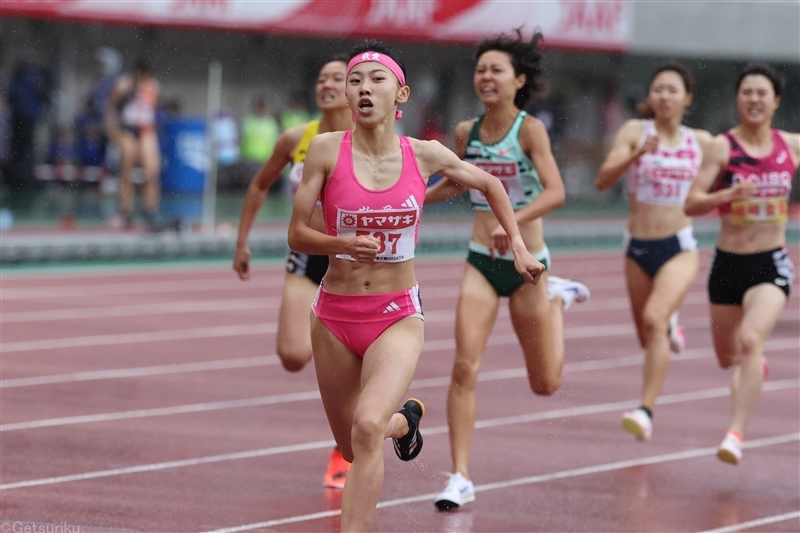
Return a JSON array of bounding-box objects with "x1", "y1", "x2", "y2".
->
[{"x1": 0, "y1": 249, "x2": 800, "y2": 532}]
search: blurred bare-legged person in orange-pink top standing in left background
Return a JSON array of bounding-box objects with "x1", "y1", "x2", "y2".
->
[{"x1": 105, "y1": 59, "x2": 161, "y2": 231}]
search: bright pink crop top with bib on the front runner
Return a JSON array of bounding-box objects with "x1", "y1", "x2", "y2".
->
[{"x1": 320, "y1": 131, "x2": 426, "y2": 263}]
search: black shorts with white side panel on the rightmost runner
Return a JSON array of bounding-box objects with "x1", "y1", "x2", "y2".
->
[{"x1": 708, "y1": 248, "x2": 794, "y2": 305}]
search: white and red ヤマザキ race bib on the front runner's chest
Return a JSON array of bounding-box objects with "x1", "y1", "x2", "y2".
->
[{"x1": 336, "y1": 208, "x2": 420, "y2": 263}]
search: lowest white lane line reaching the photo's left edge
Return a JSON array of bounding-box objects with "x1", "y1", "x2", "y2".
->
[{"x1": 0, "y1": 379, "x2": 800, "y2": 490}]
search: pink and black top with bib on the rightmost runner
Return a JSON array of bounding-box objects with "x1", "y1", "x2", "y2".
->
[{"x1": 716, "y1": 129, "x2": 797, "y2": 224}]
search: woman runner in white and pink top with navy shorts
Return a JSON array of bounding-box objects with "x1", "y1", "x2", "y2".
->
[{"x1": 595, "y1": 63, "x2": 711, "y2": 440}]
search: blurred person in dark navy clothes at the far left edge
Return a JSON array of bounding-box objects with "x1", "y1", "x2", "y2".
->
[{"x1": 8, "y1": 59, "x2": 53, "y2": 189}]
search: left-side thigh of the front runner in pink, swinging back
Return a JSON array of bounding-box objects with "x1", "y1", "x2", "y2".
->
[{"x1": 309, "y1": 311, "x2": 362, "y2": 450}]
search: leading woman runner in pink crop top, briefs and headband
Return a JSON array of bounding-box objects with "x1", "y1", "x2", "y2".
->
[{"x1": 289, "y1": 40, "x2": 544, "y2": 531}]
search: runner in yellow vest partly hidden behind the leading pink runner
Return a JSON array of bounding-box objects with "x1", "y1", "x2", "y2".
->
[{"x1": 233, "y1": 56, "x2": 353, "y2": 489}]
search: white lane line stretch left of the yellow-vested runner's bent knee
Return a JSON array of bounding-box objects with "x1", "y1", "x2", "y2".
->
[{"x1": 0, "y1": 355, "x2": 280, "y2": 389}]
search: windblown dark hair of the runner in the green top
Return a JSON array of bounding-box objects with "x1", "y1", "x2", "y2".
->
[{"x1": 475, "y1": 28, "x2": 547, "y2": 109}]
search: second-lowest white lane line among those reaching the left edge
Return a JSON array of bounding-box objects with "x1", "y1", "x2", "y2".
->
[{"x1": 0, "y1": 339, "x2": 796, "y2": 432}]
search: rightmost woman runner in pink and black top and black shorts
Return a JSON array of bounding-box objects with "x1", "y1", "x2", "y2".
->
[{"x1": 684, "y1": 64, "x2": 800, "y2": 465}]
